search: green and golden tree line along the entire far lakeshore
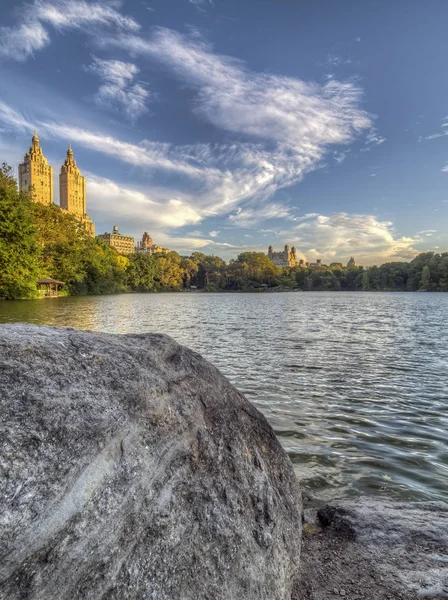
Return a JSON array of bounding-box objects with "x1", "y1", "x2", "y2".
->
[{"x1": 0, "y1": 164, "x2": 448, "y2": 300}]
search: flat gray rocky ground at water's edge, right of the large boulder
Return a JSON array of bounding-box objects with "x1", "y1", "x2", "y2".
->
[{"x1": 293, "y1": 498, "x2": 448, "y2": 600}]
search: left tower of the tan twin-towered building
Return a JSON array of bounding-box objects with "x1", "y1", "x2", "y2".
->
[{"x1": 19, "y1": 130, "x2": 53, "y2": 206}]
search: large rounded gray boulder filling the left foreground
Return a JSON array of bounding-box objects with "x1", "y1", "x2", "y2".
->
[{"x1": 0, "y1": 325, "x2": 301, "y2": 600}]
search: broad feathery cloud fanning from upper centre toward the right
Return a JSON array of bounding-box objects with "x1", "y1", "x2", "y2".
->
[{"x1": 105, "y1": 29, "x2": 371, "y2": 152}]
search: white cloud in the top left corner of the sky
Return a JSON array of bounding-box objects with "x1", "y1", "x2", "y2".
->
[{"x1": 0, "y1": 0, "x2": 139, "y2": 61}]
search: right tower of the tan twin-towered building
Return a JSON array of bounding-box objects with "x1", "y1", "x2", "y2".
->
[{"x1": 59, "y1": 146, "x2": 95, "y2": 237}]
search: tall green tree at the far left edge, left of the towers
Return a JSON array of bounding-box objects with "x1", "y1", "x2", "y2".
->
[{"x1": 0, "y1": 163, "x2": 40, "y2": 299}]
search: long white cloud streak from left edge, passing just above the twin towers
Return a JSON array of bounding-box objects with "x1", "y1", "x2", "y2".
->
[{"x1": 0, "y1": 104, "x2": 316, "y2": 215}]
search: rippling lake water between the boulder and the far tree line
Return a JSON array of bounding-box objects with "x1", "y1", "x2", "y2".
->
[{"x1": 0, "y1": 292, "x2": 448, "y2": 500}]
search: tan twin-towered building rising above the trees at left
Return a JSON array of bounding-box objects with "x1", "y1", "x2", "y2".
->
[{"x1": 19, "y1": 131, "x2": 95, "y2": 237}]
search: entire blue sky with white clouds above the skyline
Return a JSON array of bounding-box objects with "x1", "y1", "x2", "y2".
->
[{"x1": 0, "y1": 0, "x2": 448, "y2": 265}]
